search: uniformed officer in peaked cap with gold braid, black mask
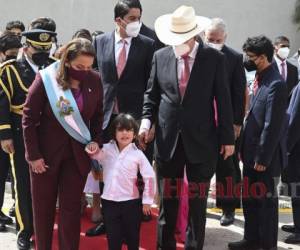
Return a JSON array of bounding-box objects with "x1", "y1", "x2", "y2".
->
[{"x1": 0, "y1": 21, "x2": 56, "y2": 250}]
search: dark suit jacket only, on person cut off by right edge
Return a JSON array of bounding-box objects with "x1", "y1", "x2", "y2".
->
[{"x1": 286, "y1": 84, "x2": 300, "y2": 182}]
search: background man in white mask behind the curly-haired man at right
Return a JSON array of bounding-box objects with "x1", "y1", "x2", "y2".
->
[{"x1": 272, "y1": 36, "x2": 299, "y2": 97}]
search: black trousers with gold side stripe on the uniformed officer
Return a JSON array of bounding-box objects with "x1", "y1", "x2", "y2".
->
[{"x1": 12, "y1": 130, "x2": 33, "y2": 238}]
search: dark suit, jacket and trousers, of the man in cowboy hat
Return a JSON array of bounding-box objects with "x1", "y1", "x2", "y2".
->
[{"x1": 143, "y1": 43, "x2": 234, "y2": 249}]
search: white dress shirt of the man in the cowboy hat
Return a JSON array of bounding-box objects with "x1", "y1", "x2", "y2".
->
[{"x1": 139, "y1": 42, "x2": 199, "y2": 134}]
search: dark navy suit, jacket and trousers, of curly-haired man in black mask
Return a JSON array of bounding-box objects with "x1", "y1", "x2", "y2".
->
[{"x1": 241, "y1": 65, "x2": 287, "y2": 249}]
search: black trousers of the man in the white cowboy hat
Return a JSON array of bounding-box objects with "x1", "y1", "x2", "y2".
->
[{"x1": 156, "y1": 137, "x2": 216, "y2": 250}]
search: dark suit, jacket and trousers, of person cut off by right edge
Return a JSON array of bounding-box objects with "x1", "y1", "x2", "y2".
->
[{"x1": 286, "y1": 84, "x2": 300, "y2": 233}]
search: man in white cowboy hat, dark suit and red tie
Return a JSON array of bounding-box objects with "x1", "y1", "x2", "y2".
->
[{"x1": 139, "y1": 6, "x2": 234, "y2": 250}]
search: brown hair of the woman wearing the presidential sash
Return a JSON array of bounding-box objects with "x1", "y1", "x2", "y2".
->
[{"x1": 57, "y1": 38, "x2": 96, "y2": 90}]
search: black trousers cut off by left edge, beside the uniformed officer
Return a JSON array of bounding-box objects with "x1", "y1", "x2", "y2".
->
[{"x1": 0, "y1": 147, "x2": 10, "y2": 210}]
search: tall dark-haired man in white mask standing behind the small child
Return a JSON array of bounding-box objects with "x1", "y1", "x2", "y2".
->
[{"x1": 87, "y1": 0, "x2": 155, "y2": 236}]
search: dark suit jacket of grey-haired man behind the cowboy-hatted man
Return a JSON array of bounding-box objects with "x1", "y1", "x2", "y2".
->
[{"x1": 221, "y1": 45, "x2": 247, "y2": 125}]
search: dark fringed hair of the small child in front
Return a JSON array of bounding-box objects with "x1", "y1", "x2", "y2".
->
[{"x1": 111, "y1": 113, "x2": 139, "y2": 140}]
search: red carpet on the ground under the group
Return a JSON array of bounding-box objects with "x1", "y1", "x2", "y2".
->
[{"x1": 52, "y1": 209, "x2": 183, "y2": 250}]
